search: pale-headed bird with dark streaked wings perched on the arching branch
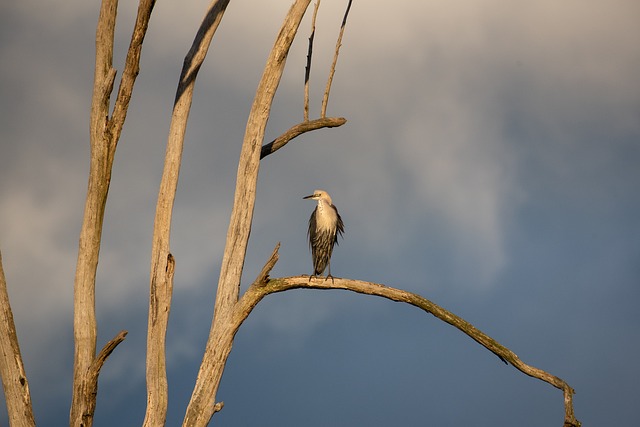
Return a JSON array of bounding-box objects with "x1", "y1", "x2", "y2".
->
[{"x1": 303, "y1": 190, "x2": 344, "y2": 281}]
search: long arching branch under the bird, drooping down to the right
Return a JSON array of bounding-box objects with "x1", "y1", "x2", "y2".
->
[{"x1": 233, "y1": 276, "x2": 580, "y2": 427}]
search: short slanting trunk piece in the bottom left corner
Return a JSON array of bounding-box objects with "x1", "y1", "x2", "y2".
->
[{"x1": 0, "y1": 253, "x2": 36, "y2": 427}]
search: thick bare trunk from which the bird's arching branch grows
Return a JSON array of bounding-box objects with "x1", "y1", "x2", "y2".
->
[{"x1": 183, "y1": 0, "x2": 310, "y2": 427}]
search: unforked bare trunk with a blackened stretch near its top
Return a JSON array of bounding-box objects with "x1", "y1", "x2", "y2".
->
[{"x1": 144, "y1": 0, "x2": 229, "y2": 427}]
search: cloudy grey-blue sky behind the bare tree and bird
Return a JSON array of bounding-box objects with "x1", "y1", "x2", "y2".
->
[{"x1": 0, "y1": 0, "x2": 640, "y2": 427}]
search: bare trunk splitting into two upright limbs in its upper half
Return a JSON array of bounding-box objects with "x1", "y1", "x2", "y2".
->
[{"x1": 69, "y1": 0, "x2": 155, "y2": 427}]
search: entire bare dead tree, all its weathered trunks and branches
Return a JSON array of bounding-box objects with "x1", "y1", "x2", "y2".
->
[{"x1": 0, "y1": 0, "x2": 580, "y2": 427}]
